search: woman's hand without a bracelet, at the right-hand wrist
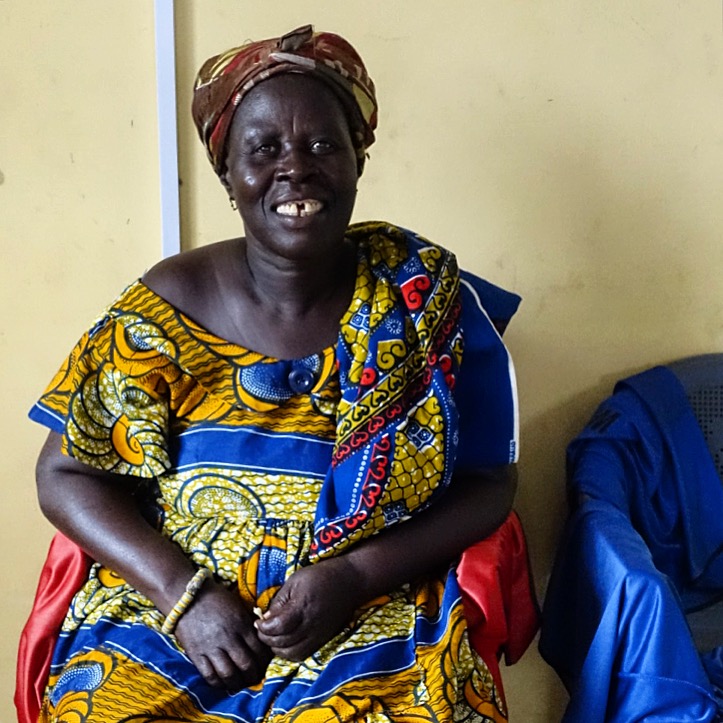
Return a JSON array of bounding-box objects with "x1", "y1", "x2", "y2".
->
[{"x1": 256, "y1": 556, "x2": 363, "y2": 661}]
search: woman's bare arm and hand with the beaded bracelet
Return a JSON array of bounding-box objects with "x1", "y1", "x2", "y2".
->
[{"x1": 36, "y1": 432, "x2": 270, "y2": 689}]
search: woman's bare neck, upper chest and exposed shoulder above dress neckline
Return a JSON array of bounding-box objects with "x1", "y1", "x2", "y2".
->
[{"x1": 144, "y1": 239, "x2": 356, "y2": 359}]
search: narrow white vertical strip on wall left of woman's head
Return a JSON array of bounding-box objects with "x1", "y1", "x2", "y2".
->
[{"x1": 154, "y1": 0, "x2": 181, "y2": 257}]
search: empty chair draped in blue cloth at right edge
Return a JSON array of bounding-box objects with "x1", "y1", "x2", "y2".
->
[{"x1": 539, "y1": 354, "x2": 723, "y2": 723}]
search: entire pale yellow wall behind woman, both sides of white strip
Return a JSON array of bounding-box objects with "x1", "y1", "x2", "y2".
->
[{"x1": 0, "y1": 0, "x2": 723, "y2": 723}]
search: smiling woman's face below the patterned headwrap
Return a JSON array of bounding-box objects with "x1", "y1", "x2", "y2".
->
[{"x1": 222, "y1": 73, "x2": 357, "y2": 260}]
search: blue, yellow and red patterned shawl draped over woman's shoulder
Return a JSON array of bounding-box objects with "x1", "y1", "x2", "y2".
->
[{"x1": 312, "y1": 222, "x2": 462, "y2": 558}]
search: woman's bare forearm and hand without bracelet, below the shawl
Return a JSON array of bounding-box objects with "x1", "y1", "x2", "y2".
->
[{"x1": 256, "y1": 465, "x2": 517, "y2": 660}]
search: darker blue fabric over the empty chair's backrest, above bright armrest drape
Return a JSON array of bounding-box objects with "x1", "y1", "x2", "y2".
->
[{"x1": 568, "y1": 367, "x2": 723, "y2": 610}]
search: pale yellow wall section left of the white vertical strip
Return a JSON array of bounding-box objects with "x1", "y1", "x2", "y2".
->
[{"x1": 0, "y1": 0, "x2": 161, "y2": 712}]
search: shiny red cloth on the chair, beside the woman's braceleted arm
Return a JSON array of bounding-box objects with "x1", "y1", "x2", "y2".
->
[{"x1": 15, "y1": 532, "x2": 91, "y2": 723}]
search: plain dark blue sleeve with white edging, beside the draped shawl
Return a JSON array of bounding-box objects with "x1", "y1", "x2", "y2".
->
[{"x1": 454, "y1": 273, "x2": 520, "y2": 470}]
